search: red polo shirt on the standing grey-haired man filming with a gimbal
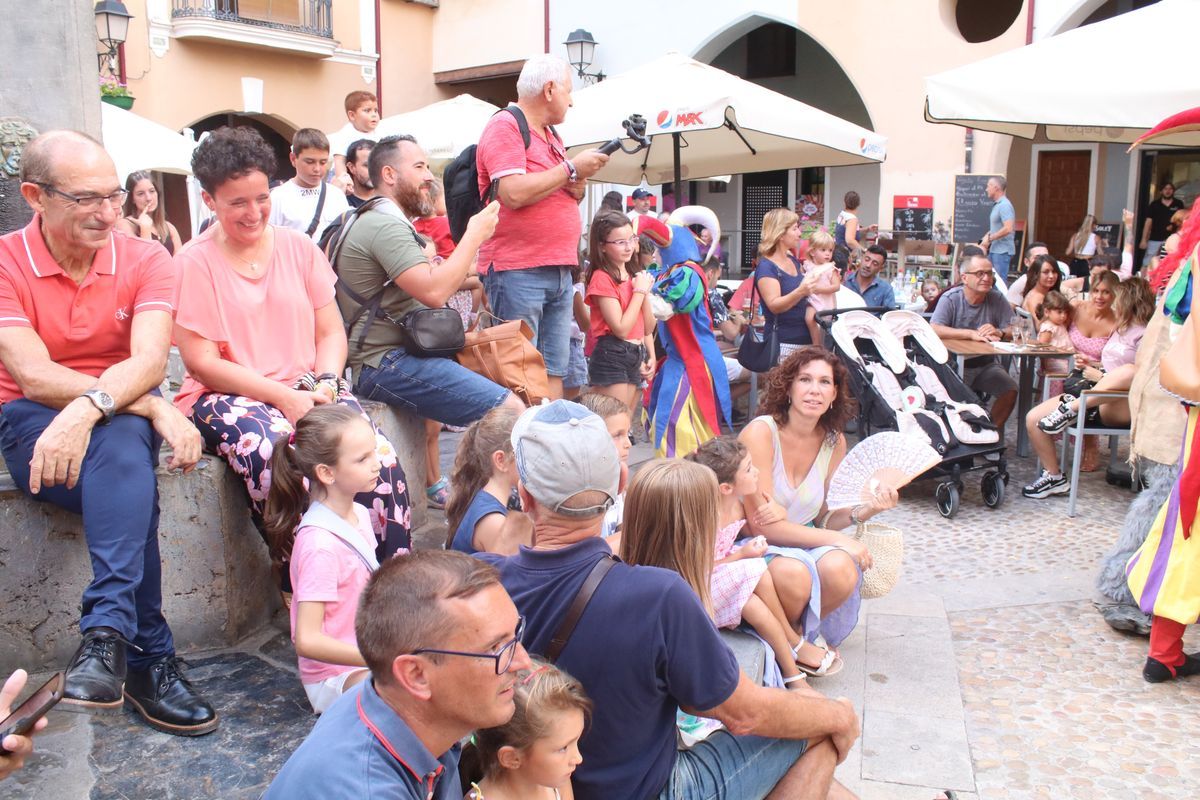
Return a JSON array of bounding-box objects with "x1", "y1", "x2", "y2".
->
[{"x1": 475, "y1": 112, "x2": 583, "y2": 272}]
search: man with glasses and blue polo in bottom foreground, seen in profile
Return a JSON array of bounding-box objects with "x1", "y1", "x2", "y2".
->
[{"x1": 264, "y1": 551, "x2": 533, "y2": 800}]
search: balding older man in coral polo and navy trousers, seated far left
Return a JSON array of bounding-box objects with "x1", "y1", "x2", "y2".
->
[{"x1": 0, "y1": 131, "x2": 217, "y2": 735}]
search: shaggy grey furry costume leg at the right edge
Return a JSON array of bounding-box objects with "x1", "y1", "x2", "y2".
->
[{"x1": 1096, "y1": 459, "x2": 1180, "y2": 636}]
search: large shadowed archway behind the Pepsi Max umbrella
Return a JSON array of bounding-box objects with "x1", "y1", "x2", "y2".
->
[{"x1": 691, "y1": 14, "x2": 880, "y2": 273}]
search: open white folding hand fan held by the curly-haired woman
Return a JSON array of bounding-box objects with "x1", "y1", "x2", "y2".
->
[{"x1": 826, "y1": 431, "x2": 942, "y2": 509}]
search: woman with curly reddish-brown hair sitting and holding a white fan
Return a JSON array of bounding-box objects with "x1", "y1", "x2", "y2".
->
[{"x1": 738, "y1": 347, "x2": 898, "y2": 675}]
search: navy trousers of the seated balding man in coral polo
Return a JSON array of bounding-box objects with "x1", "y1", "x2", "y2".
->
[{"x1": 0, "y1": 399, "x2": 175, "y2": 669}]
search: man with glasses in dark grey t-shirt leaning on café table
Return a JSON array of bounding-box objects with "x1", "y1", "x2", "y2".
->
[{"x1": 929, "y1": 255, "x2": 1016, "y2": 431}]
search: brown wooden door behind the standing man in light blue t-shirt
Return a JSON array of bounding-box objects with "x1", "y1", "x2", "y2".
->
[{"x1": 1036, "y1": 150, "x2": 1092, "y2": 258}]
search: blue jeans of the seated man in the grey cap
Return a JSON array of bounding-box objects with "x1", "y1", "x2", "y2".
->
[{"x1": 659, "y1": 730, "x2": 809, "y2": 800}]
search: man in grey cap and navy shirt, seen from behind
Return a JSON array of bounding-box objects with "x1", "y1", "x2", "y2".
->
[{"x1": 479, "y1": 401, "x2": 858, "y2": 800}]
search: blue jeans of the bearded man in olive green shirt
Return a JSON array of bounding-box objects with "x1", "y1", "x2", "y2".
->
[{"x1": 355, "y1": 348, "x2": 509, "y2": 425}]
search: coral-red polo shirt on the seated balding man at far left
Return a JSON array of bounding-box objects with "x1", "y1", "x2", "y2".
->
[{"x1": 0, "y1": 216, "x2": 176, "y2": 403}]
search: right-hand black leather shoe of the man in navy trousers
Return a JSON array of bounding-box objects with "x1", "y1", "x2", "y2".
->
[{"x1": 125, "y1": 656, "x2": 218, "y2": 736}]
